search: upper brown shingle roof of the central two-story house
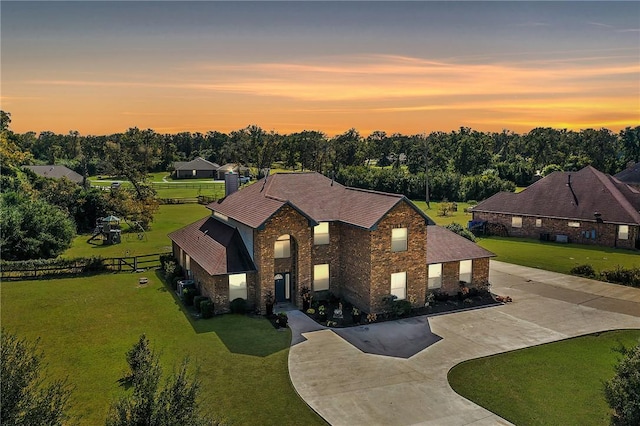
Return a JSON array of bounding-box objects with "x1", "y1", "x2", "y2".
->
[{"x1": 207, "y1": 173, "x2": 432, "y2": 229}]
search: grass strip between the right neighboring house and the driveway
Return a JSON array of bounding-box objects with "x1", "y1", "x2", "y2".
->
[{"x1": 478, "y1": 237, "x2": 640, "y2": 274}]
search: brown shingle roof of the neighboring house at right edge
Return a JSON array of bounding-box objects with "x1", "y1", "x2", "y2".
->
[{"x1": 473, "y1": 166, "x2": 640, "y2": 224}]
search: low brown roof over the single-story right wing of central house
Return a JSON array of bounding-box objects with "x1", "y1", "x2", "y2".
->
[{"x1": 427, "y1": 225, "x2": 495, "y2": 265}]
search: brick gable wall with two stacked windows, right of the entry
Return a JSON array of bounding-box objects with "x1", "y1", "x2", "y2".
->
[{"x1": 370, "y1": 201, "x2": 427, "y2": 312}]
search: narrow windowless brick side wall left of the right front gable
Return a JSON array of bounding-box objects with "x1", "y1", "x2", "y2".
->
[{"x1": 338, "y1": 224, "x2": 371, "y2": 312}]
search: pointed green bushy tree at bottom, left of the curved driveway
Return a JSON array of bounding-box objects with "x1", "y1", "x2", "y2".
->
[{"x1": 106, "y1": 334, "x2": 214, "y2": 426}]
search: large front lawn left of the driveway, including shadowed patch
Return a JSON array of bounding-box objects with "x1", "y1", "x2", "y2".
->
[{"x1": 0, "y1": 272, "x2": 323, "y2": 425}]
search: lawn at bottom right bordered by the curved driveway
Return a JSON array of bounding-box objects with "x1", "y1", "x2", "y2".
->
[{"x1": 448, "y1": 330, "x2": 640, "y2": 426}]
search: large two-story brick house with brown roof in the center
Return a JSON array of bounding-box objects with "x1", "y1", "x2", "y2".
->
[{"x1": 169, "y1": 173, "x2": 492, "y2": 312}]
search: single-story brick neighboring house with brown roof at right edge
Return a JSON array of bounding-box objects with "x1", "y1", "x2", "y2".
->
[{"x1": 473, "y1": 166, "x2": 640, "y2": 249}]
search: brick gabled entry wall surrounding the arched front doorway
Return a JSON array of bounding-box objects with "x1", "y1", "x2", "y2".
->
[{"x1": 252, "y1": 205, "x2": 313, "y2": 313}]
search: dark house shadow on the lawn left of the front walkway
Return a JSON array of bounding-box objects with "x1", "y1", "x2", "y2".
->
[{"x1": 155, "y1": 270, "x2": 291, "y2": 357}]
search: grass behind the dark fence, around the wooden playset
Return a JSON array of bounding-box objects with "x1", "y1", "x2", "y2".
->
[{"x1": 62, "y1": 204, "x2": 211, "y2": 258}]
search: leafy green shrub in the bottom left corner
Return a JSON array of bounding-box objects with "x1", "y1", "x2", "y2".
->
[{"x1": 0, "y1": 328, "x2": 72, "y2": 426}]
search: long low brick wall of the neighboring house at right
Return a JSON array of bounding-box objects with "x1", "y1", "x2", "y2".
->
[{"x1": 473, "y1": 212, "x2": 639, "y2": 249}]
